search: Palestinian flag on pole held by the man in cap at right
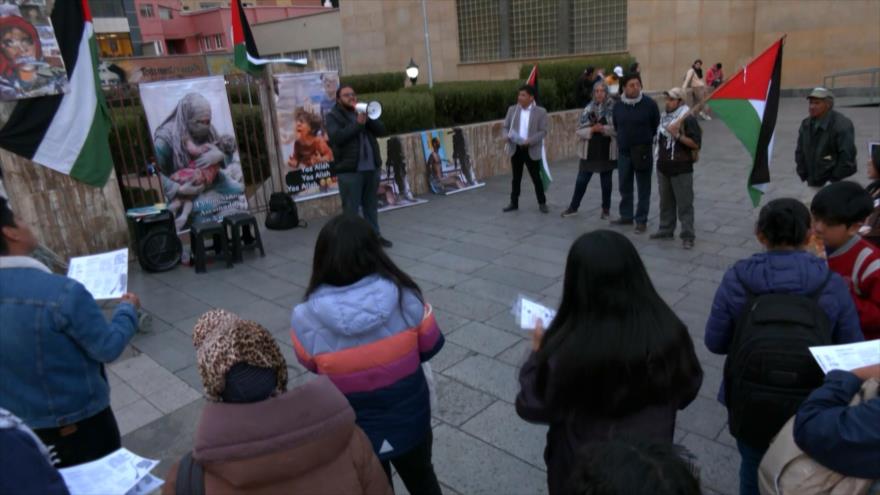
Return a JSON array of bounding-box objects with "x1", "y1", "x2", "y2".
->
[{"x1": 707, "y1": 37, "x2": 785, "y2": 207}]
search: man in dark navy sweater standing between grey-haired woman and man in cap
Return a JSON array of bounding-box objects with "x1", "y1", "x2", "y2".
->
[{"x1": 611, "y1": 74, "x2": 660, "y2": 234}]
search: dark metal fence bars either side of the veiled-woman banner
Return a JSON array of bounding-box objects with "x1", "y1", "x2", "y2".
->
[{"x1": 104, "y1": 74, "x2": 282, "y2": 213}]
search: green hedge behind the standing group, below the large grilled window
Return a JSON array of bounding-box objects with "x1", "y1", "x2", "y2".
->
[{"x1": 519, "y1": 53, "x2": 636, "y2": 110}]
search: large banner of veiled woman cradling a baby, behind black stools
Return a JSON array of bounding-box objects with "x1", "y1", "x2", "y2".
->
[{"x1": 140, "y1": 76, "x2": 248, "y2": 232}]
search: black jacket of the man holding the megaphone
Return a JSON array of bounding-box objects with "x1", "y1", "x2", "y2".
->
[{"x1": 325, "y1": 104, "x2": 385, "y2": 174}]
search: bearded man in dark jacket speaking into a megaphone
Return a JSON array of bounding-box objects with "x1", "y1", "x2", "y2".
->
[{"x1": 325, "y1": 84, "x2": 391, "y2": 248}]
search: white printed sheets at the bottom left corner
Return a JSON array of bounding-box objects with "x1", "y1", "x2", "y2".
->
[{"x1": 58, "y1": 448, "x2": 161, "y2": 495}]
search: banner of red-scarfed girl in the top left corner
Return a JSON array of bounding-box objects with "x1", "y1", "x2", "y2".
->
[{"x1": 0, "y1": 0, "x2": 68, "y2": 101}]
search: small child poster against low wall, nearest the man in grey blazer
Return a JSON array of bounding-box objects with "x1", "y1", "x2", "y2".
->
[{"x1": 421, "y1": 127, "x2": 486, "y2": 194}]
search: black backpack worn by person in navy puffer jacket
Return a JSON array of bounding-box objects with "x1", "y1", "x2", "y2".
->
[{"x1": 724, "y1": 270, "x2": 831, "y2": 448}]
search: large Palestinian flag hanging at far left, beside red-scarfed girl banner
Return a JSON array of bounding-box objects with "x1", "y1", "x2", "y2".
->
[{"x1": 0, "y1": 0, "x2": 113, "y2": 187}]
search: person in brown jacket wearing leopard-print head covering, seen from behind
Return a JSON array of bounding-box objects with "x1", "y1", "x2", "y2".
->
[{"x1": 162, "y1": 310, "x2": 392, "y2": 495}]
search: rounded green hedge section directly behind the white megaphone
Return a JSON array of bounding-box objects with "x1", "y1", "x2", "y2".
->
[{"x1": 358, "y1": 91, "x2": 435, "y2": 134}]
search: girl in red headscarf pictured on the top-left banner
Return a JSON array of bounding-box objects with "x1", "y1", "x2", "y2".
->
[{"x1": 0, "y1": 15, "x2": 67, "y2": 101}]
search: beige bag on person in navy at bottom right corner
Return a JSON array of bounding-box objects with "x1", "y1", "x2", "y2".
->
[{"x1": 758, "y1": 378, "x2": 880, "y2": 495}]
